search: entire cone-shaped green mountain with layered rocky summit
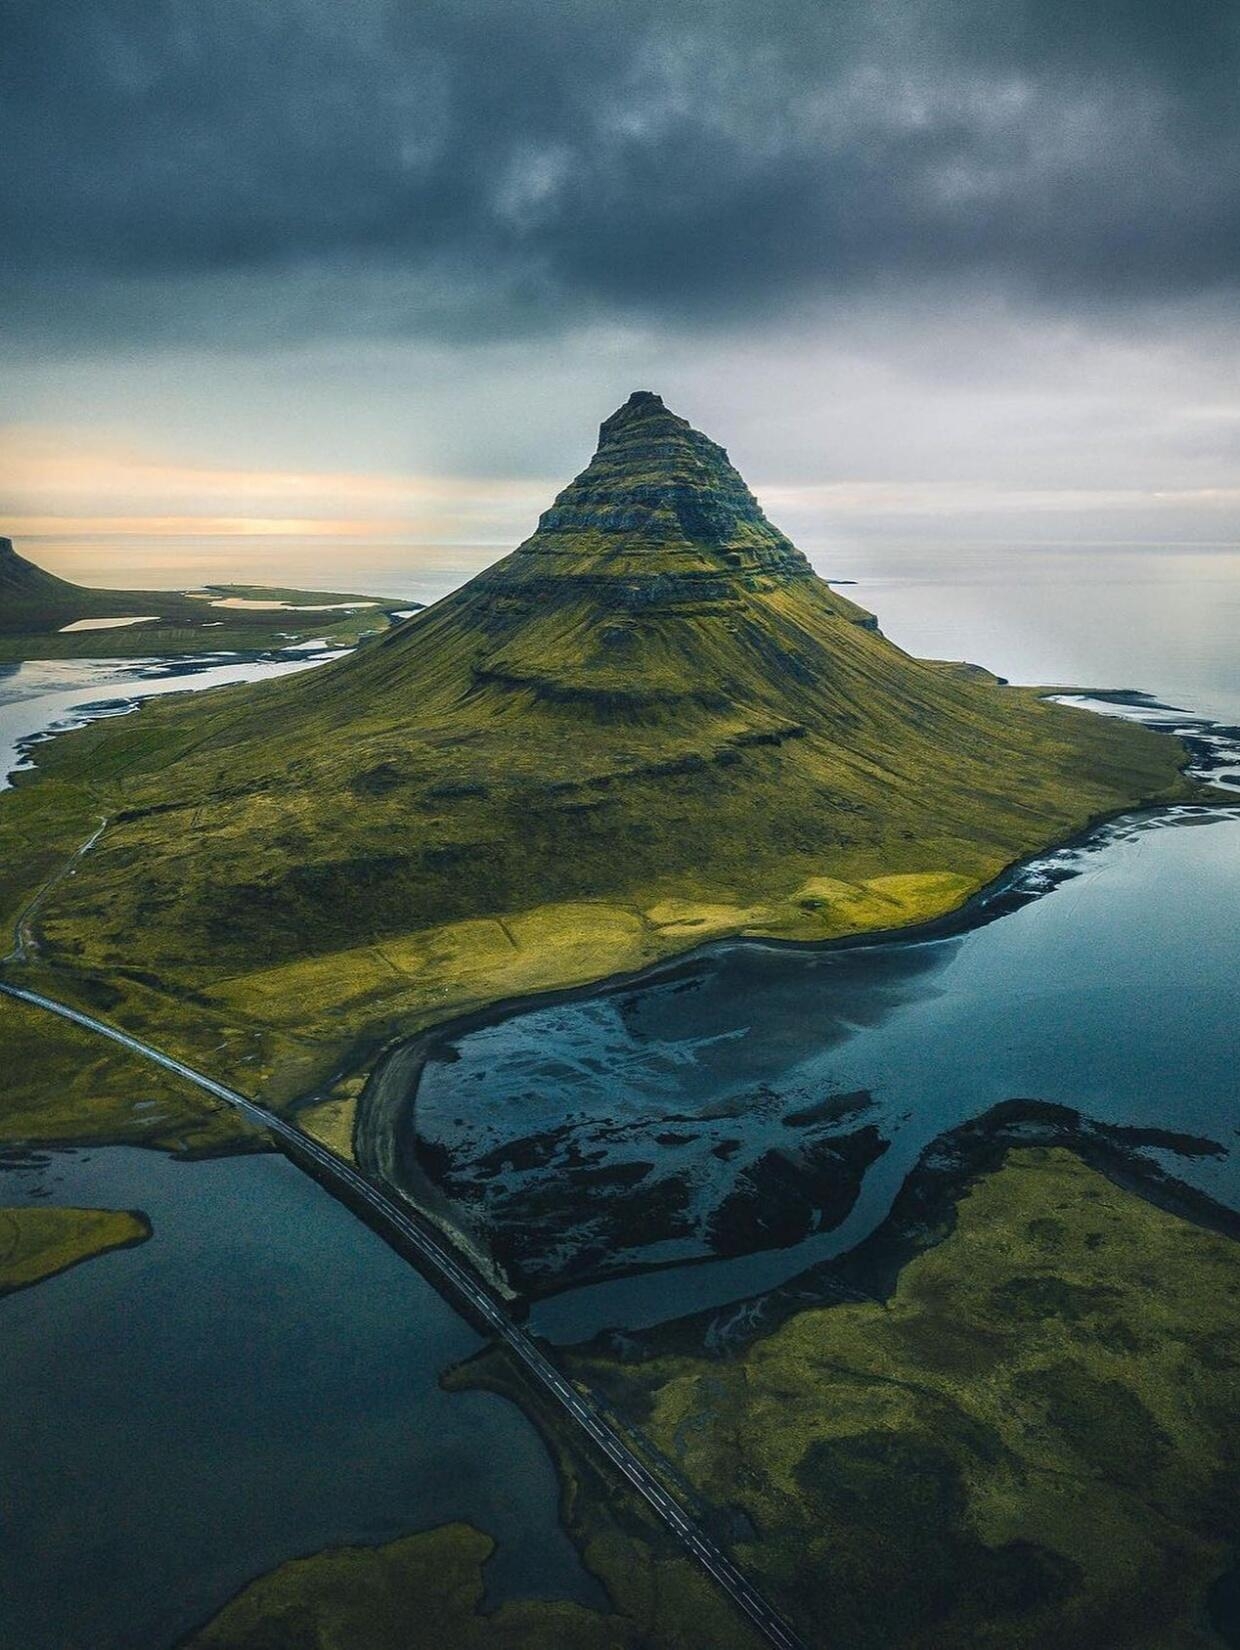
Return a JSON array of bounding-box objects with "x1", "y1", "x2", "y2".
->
[{"x1": 9, "y1": 391, "x2": 1187, "y2": 1091}]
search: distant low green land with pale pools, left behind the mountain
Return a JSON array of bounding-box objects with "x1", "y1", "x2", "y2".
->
[{"x1": 0, "y1": 538, "x2": 417, "y2": 663}]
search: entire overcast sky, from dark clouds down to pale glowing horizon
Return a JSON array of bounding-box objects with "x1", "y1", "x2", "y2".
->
[{"x1": 0, "y1": 0, "x2": 1240, "y2": 582}]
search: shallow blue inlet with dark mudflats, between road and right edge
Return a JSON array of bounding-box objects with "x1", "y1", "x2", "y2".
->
[{"x1": 404, "y1": 792, "x2": 1240, "y2": 1338}]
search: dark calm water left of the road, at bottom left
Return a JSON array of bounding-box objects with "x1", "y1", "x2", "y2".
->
[{"x1": 0, "y1": 1147, "x2": 602, "y2": 1650}]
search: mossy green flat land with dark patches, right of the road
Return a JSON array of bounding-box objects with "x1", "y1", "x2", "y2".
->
[{"x1": 577, "y1": 1148, "x2": 1240, "y2": 1650}]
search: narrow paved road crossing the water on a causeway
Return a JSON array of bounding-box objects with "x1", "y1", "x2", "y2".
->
[{"x1": 0, "y1": 980, "x2": 803, "y2": 1650}]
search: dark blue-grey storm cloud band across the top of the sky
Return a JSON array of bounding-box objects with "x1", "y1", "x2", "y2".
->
[{"x1": 0, "y1": 0, "x2": 1240, "y2": 342}]
